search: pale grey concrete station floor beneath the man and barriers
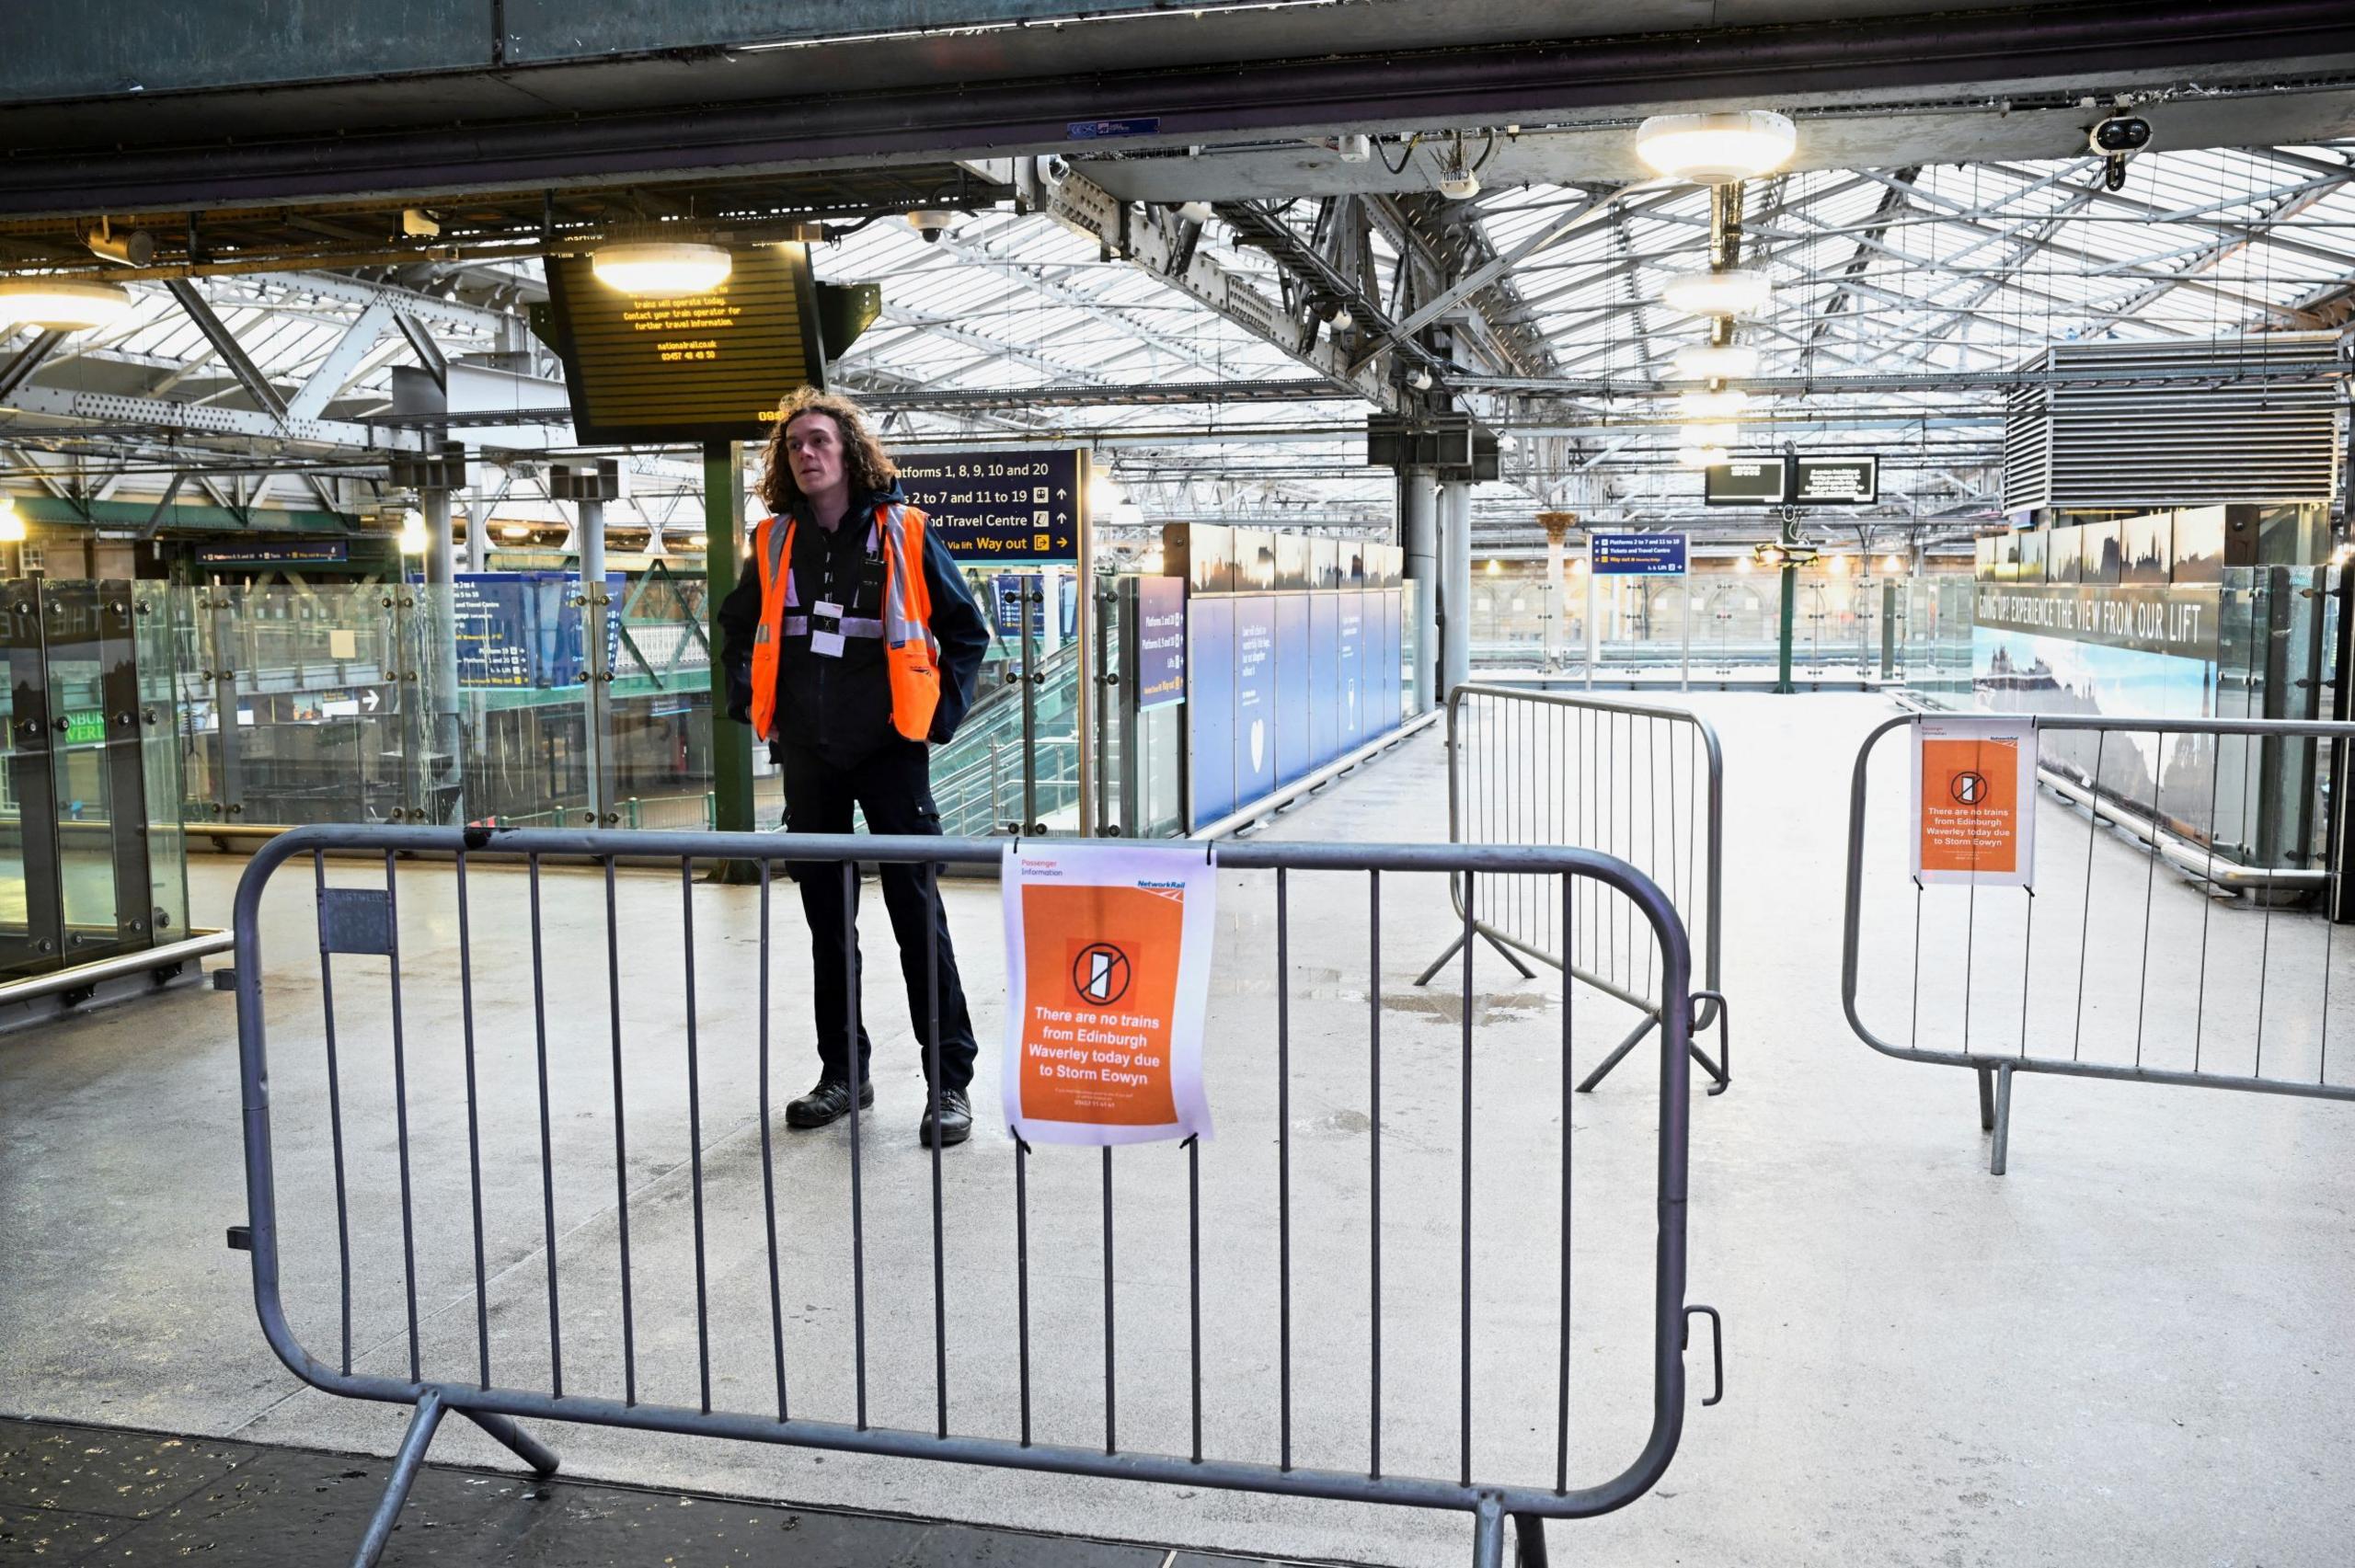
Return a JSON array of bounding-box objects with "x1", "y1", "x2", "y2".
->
[{"x1": 0, "y1": 694, "x2": 2355, "y2": 1565}]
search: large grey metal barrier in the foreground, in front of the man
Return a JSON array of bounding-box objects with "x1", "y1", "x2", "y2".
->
[{"x1": 231, "y1": 827, "x2": 1724, "y2": 1565}]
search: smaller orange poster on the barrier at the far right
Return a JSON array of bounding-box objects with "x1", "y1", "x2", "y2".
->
[{"x1": 1913, "y1": 715, "x2": 2037, "y2": 887}]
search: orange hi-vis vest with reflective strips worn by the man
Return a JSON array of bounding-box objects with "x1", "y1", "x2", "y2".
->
[{"x1": 752, "y1": 504, "x2": 939, "y2": 741}]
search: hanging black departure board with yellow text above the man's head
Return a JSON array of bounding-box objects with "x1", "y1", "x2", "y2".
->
[{"x1": 548, "y1": 245, "x2": 824, "y2": 442}]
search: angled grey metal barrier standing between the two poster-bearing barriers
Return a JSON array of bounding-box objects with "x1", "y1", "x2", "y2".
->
[{"x1": 1416, "y1": 682, "x2": 1733, "y2": 1094}]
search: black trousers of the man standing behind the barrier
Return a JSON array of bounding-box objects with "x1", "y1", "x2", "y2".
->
[{"x1": 779, "y1": 737, "x2": 980, "y2": 1090}]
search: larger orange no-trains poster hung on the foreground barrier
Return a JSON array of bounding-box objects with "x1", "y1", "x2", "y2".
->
[{"x1": 1001, "y1": 843, "x2": 1218, "y2": 1144}]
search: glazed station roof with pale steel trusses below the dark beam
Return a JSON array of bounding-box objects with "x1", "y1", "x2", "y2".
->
[{"x1": 0, "y1": 127, "x2": 2355, "y2": 555}]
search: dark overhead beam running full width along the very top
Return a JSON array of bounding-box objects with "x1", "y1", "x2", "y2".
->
[{"x1": 14, "y1": 0, "x2": 2355, "y2": 214}]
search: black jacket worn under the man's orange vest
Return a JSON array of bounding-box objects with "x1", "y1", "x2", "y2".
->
[{"x1": 720, "y1": 487, "x2": 989, "y2": 768}]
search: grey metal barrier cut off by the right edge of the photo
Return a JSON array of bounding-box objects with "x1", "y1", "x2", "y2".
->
[{"x1": 1839, "y1": 715, "x2": 2355, "y2": 1174}]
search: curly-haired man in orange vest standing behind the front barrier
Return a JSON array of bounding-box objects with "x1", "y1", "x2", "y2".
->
[{"x1": 720, "y1": 388, "x2": 989, "y2": 1147}]
